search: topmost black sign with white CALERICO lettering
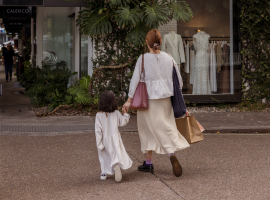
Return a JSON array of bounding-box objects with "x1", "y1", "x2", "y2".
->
[{"x1": 2, "y1": 6, "x2": 32, "y2": 18}]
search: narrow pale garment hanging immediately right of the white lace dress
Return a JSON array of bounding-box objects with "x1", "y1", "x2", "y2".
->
[{"x1": 209, "y1": 43, "x2": 217, "y2": 92}]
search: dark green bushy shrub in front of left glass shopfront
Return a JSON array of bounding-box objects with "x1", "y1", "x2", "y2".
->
[{"x1": 20, "y1": 61, "x2": 77, "y2": 109}]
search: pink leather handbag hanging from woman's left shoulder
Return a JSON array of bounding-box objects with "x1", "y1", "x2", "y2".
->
[{"x1": 129, "y1": 54, "x2": 148, "y2": 110}]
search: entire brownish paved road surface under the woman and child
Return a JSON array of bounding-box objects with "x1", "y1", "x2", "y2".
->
[{"x1": 0, "y1": 133, "x2": 270, "y2": 200}]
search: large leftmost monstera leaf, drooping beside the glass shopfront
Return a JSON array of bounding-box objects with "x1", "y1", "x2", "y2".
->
[{"x1": 77, "y1": 9, "x2": 113, "y2": 36}]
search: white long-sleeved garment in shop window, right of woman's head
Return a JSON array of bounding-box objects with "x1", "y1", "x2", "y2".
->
[{"x1": 161, "y1": 31, "x2": 186, "y2": 68}]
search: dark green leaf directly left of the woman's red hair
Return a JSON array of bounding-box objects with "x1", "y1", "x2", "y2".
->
[{"x1": 127, "y1": 23, "x2": 147, "y2": 46}]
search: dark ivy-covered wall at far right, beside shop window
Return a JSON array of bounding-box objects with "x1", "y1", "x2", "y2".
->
[{"x1": 241, "y1": 0, "x2": 270, "y2": 102}]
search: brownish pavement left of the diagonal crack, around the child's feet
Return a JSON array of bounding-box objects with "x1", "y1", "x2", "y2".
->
[{"x1": 0, "y1": 133, "x2": 181, "y2": 200}]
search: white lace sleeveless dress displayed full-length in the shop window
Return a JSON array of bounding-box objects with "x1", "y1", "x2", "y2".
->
[{"x1": 193, "y1": 31, "x2": 211, "y2": 94}]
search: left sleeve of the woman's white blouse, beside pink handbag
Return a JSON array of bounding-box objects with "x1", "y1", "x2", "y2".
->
[{"x1": 128, "y1": 55, "x2": 142, "y2": 98}]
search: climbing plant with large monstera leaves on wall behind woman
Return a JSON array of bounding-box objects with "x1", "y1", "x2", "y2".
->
[{"x1": 76, "y1": 0, "x2": 193, "y2": 101}]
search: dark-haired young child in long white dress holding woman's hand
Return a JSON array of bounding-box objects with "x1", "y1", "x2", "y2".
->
[{"x1": 95, "y1": 91, "x2": 132, "y2": 182}]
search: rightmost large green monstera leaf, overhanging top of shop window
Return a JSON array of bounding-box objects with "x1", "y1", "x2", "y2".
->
[{"x1": 168, "y1": 0, "x2": 193, "y2": 22}]
